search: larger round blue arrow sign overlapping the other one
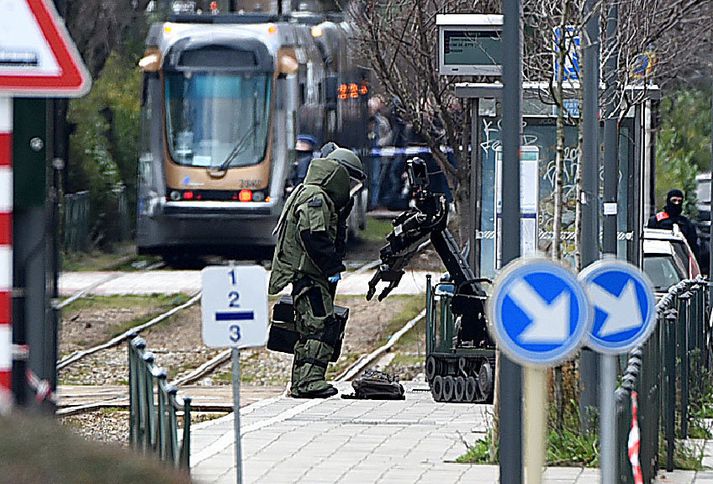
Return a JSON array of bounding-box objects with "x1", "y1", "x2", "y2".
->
[{"x1": 488, "y1": 259, "x2": 591, "y2": 366}]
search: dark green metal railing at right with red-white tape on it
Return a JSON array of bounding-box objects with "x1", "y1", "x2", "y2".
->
[{"x1": 616, "y1": 278, "x2": 713, "y2": 484}]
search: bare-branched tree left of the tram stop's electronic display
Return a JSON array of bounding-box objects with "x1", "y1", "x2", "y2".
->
[{"x1": 350, "y1": 0, "x2": 500, "y2": 242}]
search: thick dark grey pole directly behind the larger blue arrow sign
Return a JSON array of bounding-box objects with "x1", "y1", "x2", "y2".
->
[{"x1": 498, "y1": 0, "x2": 522, "y2": 484}]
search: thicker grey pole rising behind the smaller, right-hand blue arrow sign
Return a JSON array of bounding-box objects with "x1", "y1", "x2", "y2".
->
[{"x1": 580, "y1": 0, "x2": 599, "y2": 430}]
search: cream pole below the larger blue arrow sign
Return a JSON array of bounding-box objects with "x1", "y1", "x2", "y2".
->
[{"x1": 523, "y1": 366, "x2": 547, "y2": 484}]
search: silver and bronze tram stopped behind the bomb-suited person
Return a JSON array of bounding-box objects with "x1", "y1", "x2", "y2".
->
[{"x1": 137, "y1": 6, "x2": 369, "y2": 265}]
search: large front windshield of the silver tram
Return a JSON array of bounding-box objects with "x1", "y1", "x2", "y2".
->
[{"x1": 166, "y1": 72, "x2": 270, "y2": 170}]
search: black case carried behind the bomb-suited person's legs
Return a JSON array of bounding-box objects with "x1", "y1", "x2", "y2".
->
[{"x1": 267, "y1": 296, "x2": 349, "y2": 361}]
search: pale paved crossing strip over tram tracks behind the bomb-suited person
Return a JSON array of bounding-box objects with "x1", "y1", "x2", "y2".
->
[{"x1": 59, "y1": 271, "x2": 428, "y2": 297}]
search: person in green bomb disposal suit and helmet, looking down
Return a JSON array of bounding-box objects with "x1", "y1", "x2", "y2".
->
[{"x1": 269, "y1": 143, "x2": 366, "y2": 398}]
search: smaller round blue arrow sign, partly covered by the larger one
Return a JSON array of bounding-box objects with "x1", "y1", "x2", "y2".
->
[{"x1": 579, "y1": 260, "x2": 656, "y2": 354}]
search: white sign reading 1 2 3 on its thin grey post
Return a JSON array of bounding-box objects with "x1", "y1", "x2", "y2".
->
[{"x1": 201, "y1": 265, "x2": 268, "y2": 484}]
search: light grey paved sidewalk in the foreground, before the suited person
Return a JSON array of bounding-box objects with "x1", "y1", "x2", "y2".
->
[{"x1": 191, "y1": 382, "x2": 713, "y2": 484}]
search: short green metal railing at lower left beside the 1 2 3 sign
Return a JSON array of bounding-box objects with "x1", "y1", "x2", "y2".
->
[{"x1": 127, "y1": 337, "x2": 191, "y2": 471}]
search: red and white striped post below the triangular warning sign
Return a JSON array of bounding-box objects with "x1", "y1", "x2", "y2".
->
[{"x1": 0, "y1": 97, "x2": 12, "y2": 413}]
